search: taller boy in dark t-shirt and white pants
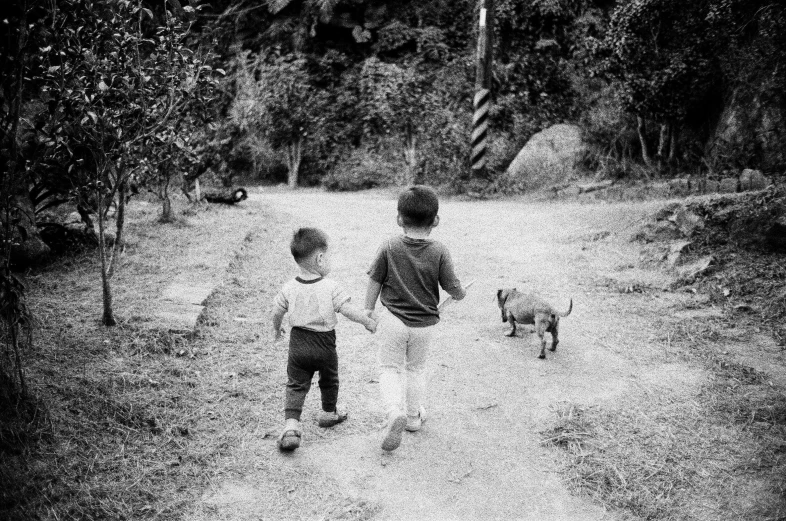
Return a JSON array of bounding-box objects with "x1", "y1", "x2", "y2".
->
[{"x1": 365, "y1": 186, "x2": 466, "y2": 451}]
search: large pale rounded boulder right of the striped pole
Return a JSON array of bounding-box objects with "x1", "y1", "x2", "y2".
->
[{"x1": 507, "y1": 124, "x2": 588, "y2": 189}]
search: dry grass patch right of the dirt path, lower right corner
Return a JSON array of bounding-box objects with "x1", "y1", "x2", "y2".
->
[{"x1": 542, "y1": 314, "x2": 786, "y2": 520}]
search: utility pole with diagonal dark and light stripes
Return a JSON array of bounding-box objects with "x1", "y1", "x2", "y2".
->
[{"x1": 471, "y1": 0, "x2": 494, "y2": 181}]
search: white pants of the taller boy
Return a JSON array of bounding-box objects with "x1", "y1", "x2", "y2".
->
[{"x1": 375, "y1": 309, "x2": 434, "y2": 416}]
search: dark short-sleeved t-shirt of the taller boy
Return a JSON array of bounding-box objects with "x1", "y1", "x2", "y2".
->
[{"x1": 368, "y1": 235, "x2": 461, "y2": 327}]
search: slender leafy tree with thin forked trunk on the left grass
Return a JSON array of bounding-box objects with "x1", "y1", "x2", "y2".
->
[{"x1": 36, "y1": 0, "x2": 214, "y2": 325}]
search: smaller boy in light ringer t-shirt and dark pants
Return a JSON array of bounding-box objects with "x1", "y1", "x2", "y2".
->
[{"x1": 273, "y1": 228, "x2": 376, "y2": 451}]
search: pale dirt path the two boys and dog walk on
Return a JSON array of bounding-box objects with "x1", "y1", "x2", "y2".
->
[{"x1": 190, "y1": 191, "x2": 702, "y2": 521}]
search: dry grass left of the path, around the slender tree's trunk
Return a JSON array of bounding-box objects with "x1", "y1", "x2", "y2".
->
[{"x1": 0, "y1": 197, "x2": 276, "y2": 519}]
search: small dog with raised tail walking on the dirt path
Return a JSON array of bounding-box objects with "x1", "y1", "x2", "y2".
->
[{"x1": 497, "y1": 288, "x2": 573, "y2": 358}]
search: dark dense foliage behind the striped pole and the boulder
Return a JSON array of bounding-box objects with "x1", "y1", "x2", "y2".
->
[{"x1": 198, "y1": 0, "x2": 786, "y2": 189}]
